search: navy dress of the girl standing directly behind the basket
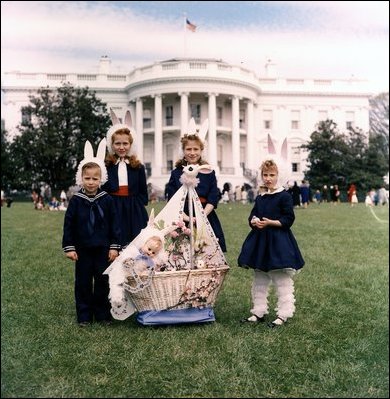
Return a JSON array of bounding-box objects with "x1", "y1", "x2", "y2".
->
[{"x1": 166, "y1": 167, "x2": 226, "y2": 252}]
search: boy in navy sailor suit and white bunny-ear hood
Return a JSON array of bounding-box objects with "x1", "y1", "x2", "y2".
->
[{"x1": 62, "y1": 139, "x2": 120, "y2": 327}]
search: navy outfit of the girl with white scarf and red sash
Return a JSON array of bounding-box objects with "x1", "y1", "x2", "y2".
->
[{"x1": 102, "y1": 164, "x2": 148, "y2": 247}]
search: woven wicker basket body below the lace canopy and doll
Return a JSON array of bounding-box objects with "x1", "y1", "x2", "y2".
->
[{"x1": 124, "y1": 265, "x2": 229, "y2": 311}]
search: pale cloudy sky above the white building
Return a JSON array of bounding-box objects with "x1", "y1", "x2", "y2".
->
[{"x1": 1, "y1": 1, "x2": 389, "y2": 94}]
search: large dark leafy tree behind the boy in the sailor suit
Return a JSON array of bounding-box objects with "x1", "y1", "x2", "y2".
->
[{"x1": 9, "y1": 83, "x2": 110, "y2": 190}]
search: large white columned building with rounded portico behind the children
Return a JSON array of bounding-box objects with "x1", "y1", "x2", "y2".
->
[{"x1": 2, "y1": 56, "x2": 372, "y2": 189}]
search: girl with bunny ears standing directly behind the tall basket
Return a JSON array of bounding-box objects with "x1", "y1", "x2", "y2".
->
[{"x1": 166, "y1": 118, "x2": 226, "y2": 252}]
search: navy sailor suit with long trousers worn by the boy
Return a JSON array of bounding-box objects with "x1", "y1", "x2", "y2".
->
[{"x1": 62, "y1": 189, "x2": 121, "y2": 323}]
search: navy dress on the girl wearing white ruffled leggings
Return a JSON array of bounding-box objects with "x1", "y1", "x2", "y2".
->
[{"x1": 238, "y1": 190, "x2": 305, "y2": 272}]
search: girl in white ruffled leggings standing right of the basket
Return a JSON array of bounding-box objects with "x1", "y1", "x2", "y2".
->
[{"x1": 238, "y1": 138, "x2": 305, "y2": 327}]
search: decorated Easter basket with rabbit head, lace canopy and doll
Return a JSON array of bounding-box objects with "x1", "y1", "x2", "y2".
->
[{"x1": 105, "y1": 119, "x2": 229, "y2": 325}]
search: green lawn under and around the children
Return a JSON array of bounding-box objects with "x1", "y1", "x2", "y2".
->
[{"x1": 1, "y1": 202, "x2": 389, "y2": 398}]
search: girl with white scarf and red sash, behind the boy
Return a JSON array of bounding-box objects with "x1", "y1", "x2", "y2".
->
[{"x1": 102, "y1": 110, "x2": 148, "y2": 247}]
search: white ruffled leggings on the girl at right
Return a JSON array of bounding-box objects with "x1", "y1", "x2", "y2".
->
[{"x1": 251, "y1": 269, "x2": 295, "y2": 320}]
